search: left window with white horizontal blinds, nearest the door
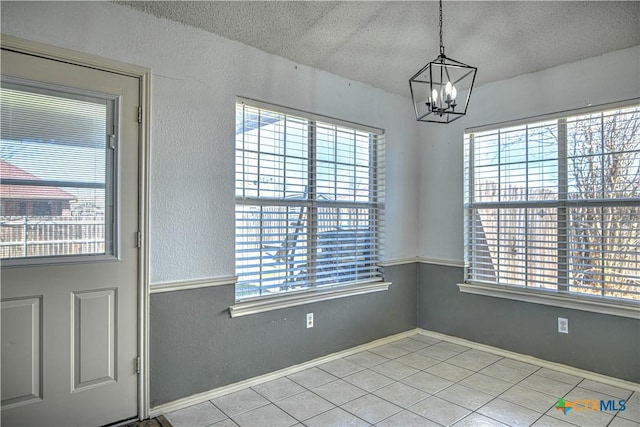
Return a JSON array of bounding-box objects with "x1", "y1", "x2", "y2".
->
[{"x1": 235, "y1": 102, "x2": 384, "y2": 300}]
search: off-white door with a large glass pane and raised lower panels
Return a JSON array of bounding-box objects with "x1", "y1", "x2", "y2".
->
[{"x1": 0, "y1": 49, "x2": 140, "y2": 426}]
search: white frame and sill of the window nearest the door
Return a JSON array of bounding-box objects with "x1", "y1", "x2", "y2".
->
[{"x1": 230, "y1": 97, "x2": 390, "y2": 310}]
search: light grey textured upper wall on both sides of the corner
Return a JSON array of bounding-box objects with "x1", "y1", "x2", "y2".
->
[{"x1": 6, "y1": 1, "x2": 640, "y2": 283}]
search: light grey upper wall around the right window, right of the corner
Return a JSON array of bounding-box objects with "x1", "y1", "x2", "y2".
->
[{"x1": 418, "y1": 46, "x2": 640, "y2": 261}]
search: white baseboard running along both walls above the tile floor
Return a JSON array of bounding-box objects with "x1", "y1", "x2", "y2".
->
[{"x1": 149, "y1": 328, "x2": 640, "y2": 418}]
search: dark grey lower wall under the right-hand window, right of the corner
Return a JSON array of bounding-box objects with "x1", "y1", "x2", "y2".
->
[{"x1": 418, "y1": 264, "x2": 640, "y2": 382}]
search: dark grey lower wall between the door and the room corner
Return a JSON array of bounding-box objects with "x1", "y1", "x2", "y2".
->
[{"x1": 150, "y1": 264, "x2": 417, "y2": 407}]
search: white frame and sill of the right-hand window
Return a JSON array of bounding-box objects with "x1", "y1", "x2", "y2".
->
[{"x1": 458, "y1": 98, "x2": 640, "y2": 319}]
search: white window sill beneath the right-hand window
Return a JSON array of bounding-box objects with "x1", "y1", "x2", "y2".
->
[{"x1": 458, "y1": 283, "x2": 640, "y2": 319}]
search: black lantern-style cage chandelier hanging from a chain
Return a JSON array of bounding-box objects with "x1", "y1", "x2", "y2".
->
[{"x1": 409, "y1": 0, "x2": 478, "y2": 123}]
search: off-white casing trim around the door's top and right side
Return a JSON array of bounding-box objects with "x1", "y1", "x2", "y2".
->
[{"x1": 0, "y1": 34, "x2": 151, "y2": 421}]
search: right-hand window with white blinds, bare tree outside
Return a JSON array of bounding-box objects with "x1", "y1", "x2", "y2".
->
[{"x1": 465, "y1": 105, "x2": 640, "y2": 301}]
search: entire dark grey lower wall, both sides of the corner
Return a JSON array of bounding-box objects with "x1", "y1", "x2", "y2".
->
[{"x1": 150, "y1": 264, "x2": 640, "y2": 407}]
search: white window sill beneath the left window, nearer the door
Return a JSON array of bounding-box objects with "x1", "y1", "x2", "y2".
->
[{"x1": 229, "y1": 282, "x2": 391, "y2": 317}]
